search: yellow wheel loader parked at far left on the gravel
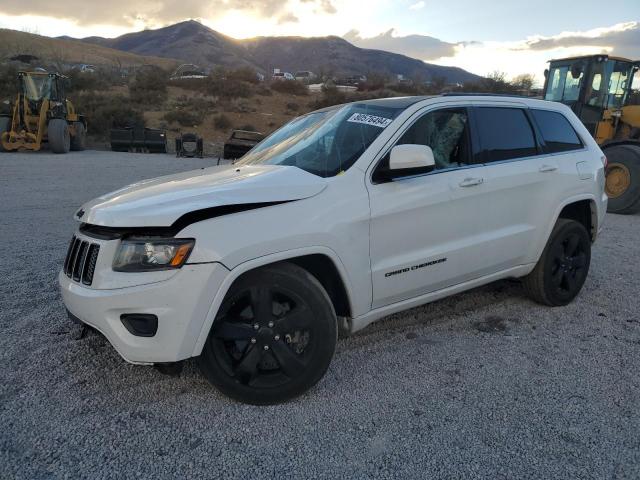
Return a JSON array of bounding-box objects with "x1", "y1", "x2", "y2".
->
[{"x1": 0, "y1": 72, "x2": 87, "y2": 153}]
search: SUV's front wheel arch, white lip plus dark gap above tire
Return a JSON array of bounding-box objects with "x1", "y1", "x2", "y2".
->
[{"x1": 192, "y1": 246, "x2": 353, "y2": 357}]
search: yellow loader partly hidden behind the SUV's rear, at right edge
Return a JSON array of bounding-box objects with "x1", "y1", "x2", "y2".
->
[{"x1": 544, "y1": 54, "x2": 640, "y2": 214}]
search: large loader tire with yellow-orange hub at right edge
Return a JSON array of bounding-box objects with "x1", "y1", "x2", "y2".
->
[{"x1": 604, "y1": 144, "x2": 640, "y2": 215}]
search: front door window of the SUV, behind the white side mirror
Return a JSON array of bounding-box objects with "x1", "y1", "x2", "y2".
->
[{"x1": 396, "y1": 108, "x2": 469, "y2": 169}]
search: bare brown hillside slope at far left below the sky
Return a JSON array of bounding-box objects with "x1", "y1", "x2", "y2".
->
[{"x1": 0, "y1": 29, "x2": 176, "y2": 69}]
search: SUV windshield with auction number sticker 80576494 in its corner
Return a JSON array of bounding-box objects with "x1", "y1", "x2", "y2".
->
[{"x1": 239, "y1": 104, "x2": 400, "y2": 177}]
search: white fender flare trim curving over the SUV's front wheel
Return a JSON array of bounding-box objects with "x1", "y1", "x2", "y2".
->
[{"x1": 192, "y1": 245, "x2": 353, "y2": 357}]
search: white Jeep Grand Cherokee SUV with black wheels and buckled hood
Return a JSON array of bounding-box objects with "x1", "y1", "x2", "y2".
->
[{"x1": 59, "y1": 95, "x2": 607, "y2": 404}]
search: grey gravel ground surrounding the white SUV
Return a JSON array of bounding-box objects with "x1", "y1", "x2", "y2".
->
[{"x1": 0, "y1": 152, "x2": 640, "y2": 479}]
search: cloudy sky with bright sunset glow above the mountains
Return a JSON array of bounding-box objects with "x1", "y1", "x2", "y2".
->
[{"x1": 0, "y1": 0, "x2": 640, "y2": 79}]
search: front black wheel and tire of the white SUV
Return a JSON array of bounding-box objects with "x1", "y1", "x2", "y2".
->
[{"x1": 198, "y1": 263, "x2": 338, "y2": 405}]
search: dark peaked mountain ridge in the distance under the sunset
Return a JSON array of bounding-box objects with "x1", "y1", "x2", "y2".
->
[{"x1": 80, "y1": 20, "x2": 480, "y2": 82}]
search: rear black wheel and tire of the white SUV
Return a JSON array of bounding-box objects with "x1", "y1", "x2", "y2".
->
[{"x1": 522, "y1": 218, "x2": 591, "y2": 307}]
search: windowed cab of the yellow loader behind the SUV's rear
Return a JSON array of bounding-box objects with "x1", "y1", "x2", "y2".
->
[{"x1": 544, "y1": 55, "x2": 640, "y2": 142}]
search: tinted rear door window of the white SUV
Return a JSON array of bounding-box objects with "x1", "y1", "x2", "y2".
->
[{"x1": 476, "y1": 107, "x2": 538, "y2": 162}]
